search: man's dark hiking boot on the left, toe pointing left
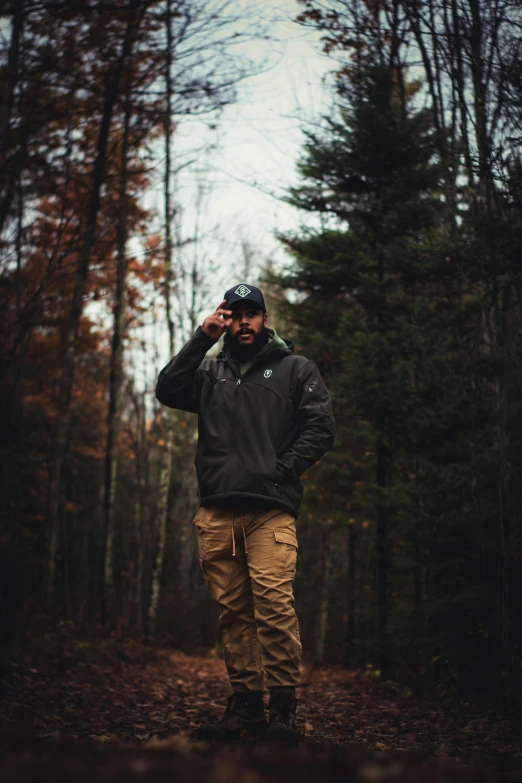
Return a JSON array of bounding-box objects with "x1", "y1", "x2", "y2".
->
[{"x1": 197, "y1": 691, "x2": 266, "y2": 742}]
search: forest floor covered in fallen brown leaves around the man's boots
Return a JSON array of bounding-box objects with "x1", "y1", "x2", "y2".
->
[{"x1": 0, "y1": 640, "x2": 522, "y2": 783}]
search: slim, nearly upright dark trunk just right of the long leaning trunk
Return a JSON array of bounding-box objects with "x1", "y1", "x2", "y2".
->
[{"x1": 103, "y1": 89, "x2": 131, "y2": 631}]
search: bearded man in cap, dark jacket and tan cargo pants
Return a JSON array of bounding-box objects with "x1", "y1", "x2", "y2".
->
[{"x1": 156, "y1": 283, "x2": 334, "y2": 745}]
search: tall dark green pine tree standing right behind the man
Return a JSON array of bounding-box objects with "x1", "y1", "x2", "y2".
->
[{"x1": 279, "y1": 64, "x2": 478, "y2": 676}]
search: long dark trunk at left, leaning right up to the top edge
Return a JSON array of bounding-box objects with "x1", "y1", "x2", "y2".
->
[{"x1": 45, "y1": 0, "x2": 139, "y2": 604}]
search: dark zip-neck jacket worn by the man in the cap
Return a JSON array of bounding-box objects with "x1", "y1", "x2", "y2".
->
[{"x1": 156, "y1": 327, "x2": 335, "y2": 515}]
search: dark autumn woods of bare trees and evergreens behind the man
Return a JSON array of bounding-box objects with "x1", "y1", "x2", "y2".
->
[{"x1": 0, "y1": 0, "x2": 522, "y2": 780}]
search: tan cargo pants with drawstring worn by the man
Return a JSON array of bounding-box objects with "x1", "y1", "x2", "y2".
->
[{"x1": 194, "y1": 506, "x2": 301, "y2": 691}]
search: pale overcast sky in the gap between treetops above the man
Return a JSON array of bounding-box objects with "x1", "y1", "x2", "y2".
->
[{"x1": 152, "y1": 0, "x2": 334, "y2": 282}]
